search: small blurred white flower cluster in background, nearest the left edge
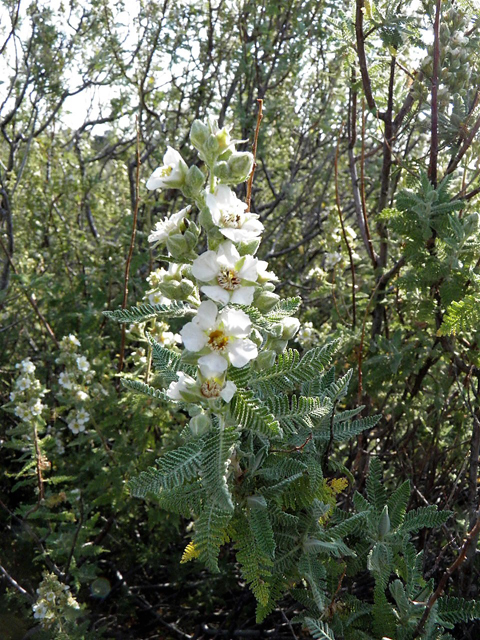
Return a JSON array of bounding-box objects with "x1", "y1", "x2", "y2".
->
[{"x1": 10, "y1": 358, "x2": 46, "y2": 422}]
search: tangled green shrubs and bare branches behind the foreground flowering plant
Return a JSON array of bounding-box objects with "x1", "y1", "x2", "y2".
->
[{"x1": 0, "y1": 0, "x2": 480, "y2": 639}]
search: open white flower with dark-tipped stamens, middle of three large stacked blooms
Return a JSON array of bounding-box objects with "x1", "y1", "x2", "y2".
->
[{"x1": 192, "y1": 242, "x2": 267, "y2": 305}]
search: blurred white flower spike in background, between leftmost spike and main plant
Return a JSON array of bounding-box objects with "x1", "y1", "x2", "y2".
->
[{"x1": 56, "y1": 333, "x2": 94, "y2": 435}]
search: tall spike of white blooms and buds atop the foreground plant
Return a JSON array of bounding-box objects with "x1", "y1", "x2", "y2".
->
[{"x1": 146, "y1": 119, "x2": 299, "y2": 428}]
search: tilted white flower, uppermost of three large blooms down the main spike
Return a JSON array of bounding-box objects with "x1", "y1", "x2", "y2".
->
[{"x1": 205, "y1": 184, "x2": 263, "y2": 242}]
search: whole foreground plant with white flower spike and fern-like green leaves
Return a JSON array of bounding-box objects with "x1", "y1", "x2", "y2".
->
[{"x1": 106, "y1": 119, "x2": 478, "y2": 640}]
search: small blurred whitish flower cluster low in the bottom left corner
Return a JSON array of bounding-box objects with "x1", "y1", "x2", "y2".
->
[{"x1": 32, "y1": 573, "x2": 80, "y2": 630}]
